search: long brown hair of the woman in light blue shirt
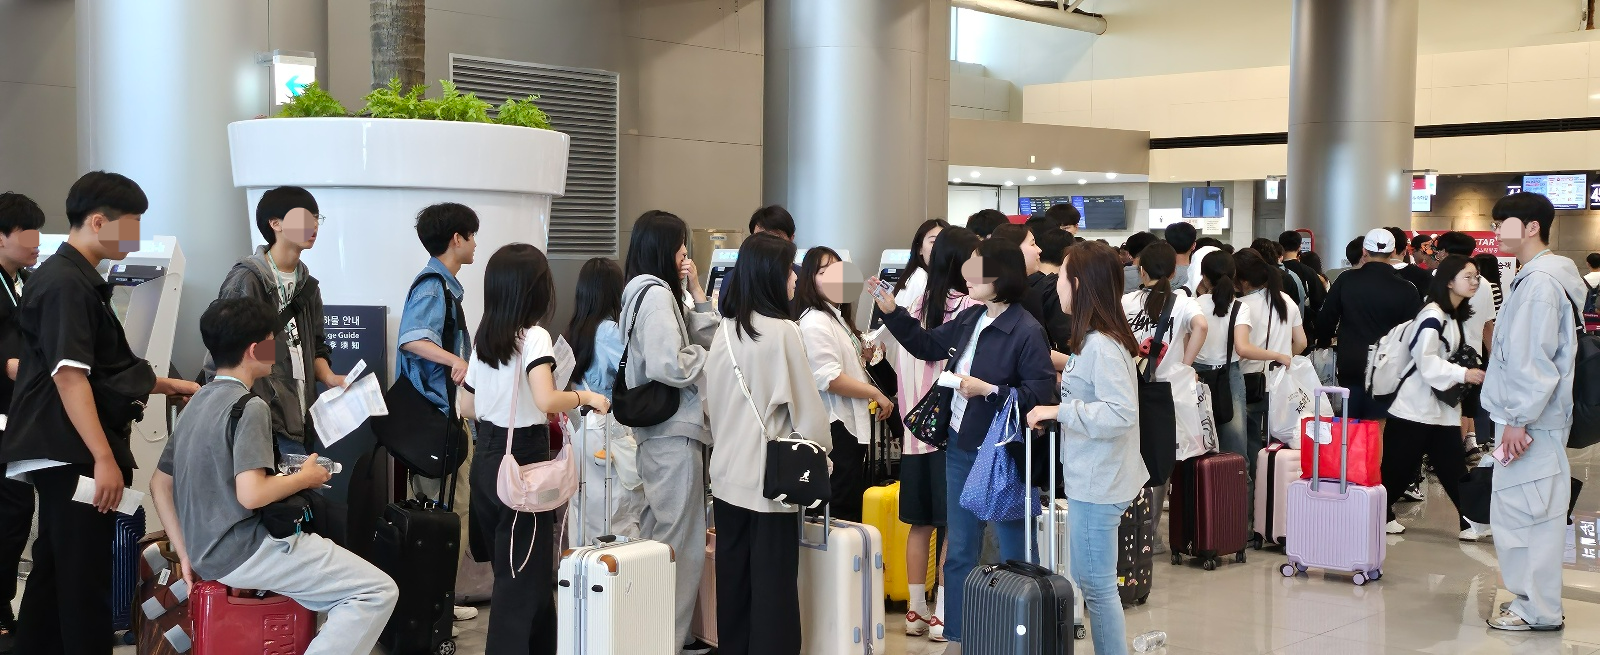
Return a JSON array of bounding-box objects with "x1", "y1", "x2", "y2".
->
[{"x1": 1061, "y1": 242, "x2": 1139, "y2": 357}]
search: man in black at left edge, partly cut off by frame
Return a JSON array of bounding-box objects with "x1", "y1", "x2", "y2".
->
[{"x1": 0, "y1": 192, "x2": 45, "y2": 653}]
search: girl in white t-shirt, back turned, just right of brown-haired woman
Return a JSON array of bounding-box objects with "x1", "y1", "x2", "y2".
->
[{"x1": 1122, "y1": 242, "x2": 1210, "y2": 554}]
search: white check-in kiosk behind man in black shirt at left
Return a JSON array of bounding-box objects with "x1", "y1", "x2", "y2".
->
[{"x1": 38, "y1": 234, "x2": 184, "y2": 530}]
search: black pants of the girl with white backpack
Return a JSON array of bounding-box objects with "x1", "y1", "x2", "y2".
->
[{"x1": 1382, "y1": 416, "x2": 1467, "y2": 528}]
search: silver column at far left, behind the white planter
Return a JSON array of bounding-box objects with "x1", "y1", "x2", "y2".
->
[{"x1": 75, "y1": 0, "x2": 315, "y2": 376}]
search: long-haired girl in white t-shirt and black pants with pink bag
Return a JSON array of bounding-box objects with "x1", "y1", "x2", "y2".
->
[{"x1": 458, "y1": 243, "x2": 611, "y2": 653}]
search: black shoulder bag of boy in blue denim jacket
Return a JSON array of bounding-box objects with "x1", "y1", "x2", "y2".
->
[{"x1": 373, "y1": 272, "x2": 467, "y2": 480}]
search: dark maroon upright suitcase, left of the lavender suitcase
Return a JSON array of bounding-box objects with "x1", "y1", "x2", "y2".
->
[{"x1": 1168, "y1": 453, "x2": 1250, "y2": 570}]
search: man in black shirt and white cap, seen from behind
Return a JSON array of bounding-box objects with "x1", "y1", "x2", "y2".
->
[{"x1": 1317, "y1": 229, "x2": 1422, "y2": 420}]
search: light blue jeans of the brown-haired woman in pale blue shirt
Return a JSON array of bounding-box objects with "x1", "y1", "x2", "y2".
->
[{"x1": 1068, "y1": 500, "x2": 1130, "y2": 655}]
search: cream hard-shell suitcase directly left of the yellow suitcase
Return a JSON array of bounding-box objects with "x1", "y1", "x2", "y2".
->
[{"x1": 800, "y1": 511, "x2": 885, "y2": 655}]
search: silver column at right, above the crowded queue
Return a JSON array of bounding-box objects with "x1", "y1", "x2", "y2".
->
[{"x1": 1285, "y1": 0, "x2": 1418, "y2": 261}]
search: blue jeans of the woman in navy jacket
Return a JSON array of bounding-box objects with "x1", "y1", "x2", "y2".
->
[{"x1": 944, "y1": 431, "x2": 1030, "y2": 642}]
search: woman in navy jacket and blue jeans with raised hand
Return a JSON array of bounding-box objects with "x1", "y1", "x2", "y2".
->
[{"x1": 869, "y1": 239, "x2": 1059, "y2": 642}]
